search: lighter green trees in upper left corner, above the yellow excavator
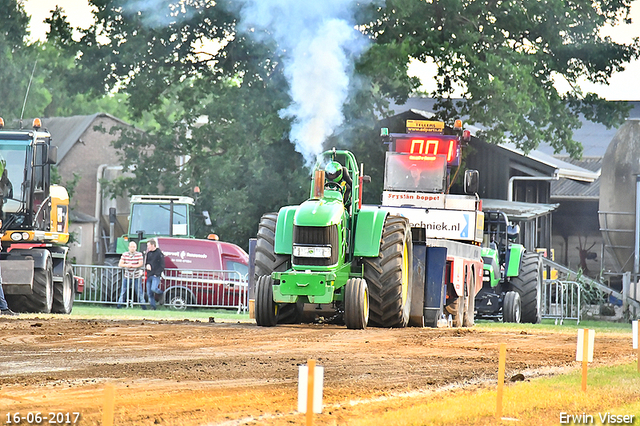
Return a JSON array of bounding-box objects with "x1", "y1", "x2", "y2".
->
[{"x1": 0, "y1": 0, "x2": 129, "y2": 122}]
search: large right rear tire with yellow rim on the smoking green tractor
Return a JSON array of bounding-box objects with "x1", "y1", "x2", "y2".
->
[{"x1": 363, "y1": 216, "x2": 413, "y2": 327}]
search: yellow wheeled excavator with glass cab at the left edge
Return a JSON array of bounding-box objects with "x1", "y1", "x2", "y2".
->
[{"x1": 0, "y1": 118, "x2": 78, "y2": 314}]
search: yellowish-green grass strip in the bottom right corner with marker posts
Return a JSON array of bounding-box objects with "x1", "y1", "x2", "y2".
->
[{"x1": 348, "y1": 363, "x2": 640, "y2": 426}]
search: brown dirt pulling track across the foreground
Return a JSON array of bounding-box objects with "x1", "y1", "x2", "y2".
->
[{"x1": 0, "y1": 317, "x2": 632, "y2": 425}]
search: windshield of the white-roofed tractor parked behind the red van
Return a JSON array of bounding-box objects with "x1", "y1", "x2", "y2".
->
[{"x1": 129, "y1": 203, "x2": 189, "y2": 236}]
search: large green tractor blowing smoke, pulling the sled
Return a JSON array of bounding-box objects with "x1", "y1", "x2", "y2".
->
[{"x1": 255, "y1": 149, "x2": 412, "y2": 329}]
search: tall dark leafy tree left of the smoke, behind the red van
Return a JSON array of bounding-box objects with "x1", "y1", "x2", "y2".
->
[{"x1": 70, "y1": 2, "x2": 316, "y2": 248}]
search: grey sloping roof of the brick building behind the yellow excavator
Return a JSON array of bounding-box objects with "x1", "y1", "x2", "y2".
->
[{"x1": 42, "y1": 112, "x2": 130, "y2": 161}]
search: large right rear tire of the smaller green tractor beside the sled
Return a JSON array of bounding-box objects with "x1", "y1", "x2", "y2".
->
[{"x1": 511, "y1": 252, "x2": 542, "y2": 324}]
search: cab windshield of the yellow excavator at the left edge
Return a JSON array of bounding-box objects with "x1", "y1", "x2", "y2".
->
[{"x1": 0, "y1": 139, "x2": 30, "y2": 213}]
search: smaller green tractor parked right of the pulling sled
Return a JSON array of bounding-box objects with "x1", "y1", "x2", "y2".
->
[{"x1": 475, "y1": 211, "x2": 542, "y2": 324}]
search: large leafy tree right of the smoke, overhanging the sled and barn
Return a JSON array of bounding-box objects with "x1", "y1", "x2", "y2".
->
[{"x1": 367, "y1": 0, "x2": 640, "y2": 157}]
